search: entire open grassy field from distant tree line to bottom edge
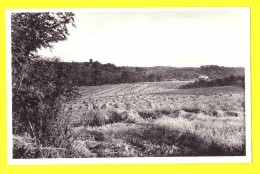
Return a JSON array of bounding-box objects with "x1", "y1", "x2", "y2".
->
[{"x1": 51, "y1": 82, "x2": 245, "y2": 157}]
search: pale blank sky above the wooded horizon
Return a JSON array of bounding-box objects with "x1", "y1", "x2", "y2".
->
[{"x1": 35, "y1": 8, "x2": 250, "y2": 67}]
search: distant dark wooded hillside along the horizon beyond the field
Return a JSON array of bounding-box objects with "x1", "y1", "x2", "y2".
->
[{"x1": 57, "y1": 61, "x2": 244, "y2": 86}]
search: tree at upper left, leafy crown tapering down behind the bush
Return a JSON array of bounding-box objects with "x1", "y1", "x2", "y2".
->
[{"x1": 11, "y1": 12, "x2": 75, "y2": 90}]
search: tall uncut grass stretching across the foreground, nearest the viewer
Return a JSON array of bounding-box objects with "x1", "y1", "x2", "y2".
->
[{"x1": 15, "y1": 104, "x2": 245, "y2": 158}]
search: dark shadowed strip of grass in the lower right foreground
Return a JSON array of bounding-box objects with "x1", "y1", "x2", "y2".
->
[{"x1": 123, "y1": 125, "x2": 245, "y2": 156}]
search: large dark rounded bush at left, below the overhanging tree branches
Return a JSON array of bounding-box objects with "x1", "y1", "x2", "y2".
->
[{"x1": 12, "y1": 58, "x2": 76, "y2": 146}]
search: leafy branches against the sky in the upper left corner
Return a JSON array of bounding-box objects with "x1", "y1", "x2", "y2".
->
[{"x1": 11, "y1": 12, "x2": 74, "y2": 56}]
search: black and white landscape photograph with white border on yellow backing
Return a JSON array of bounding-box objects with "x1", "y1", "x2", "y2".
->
[{"x1": 7, "y1": 7, "x2": 251, "y2": 164}]
